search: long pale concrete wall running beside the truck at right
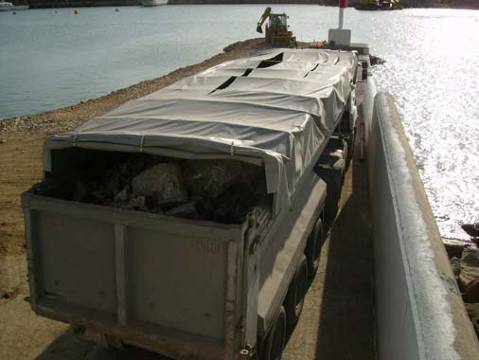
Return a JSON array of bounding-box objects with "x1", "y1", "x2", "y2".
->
[{"x1": 363, "y1": 93, "x2": 479, "y2": 360}]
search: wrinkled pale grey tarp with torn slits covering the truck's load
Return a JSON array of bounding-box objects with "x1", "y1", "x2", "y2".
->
[{"x1": 45, "y1": 49, "x2": 357, "y2": 211}]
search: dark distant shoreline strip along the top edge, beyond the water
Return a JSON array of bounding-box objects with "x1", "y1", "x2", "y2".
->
[{"x1": 12, "y1": 0, "x2": 479, "y2": 10}]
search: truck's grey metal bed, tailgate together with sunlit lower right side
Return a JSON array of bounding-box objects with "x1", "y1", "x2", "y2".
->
[{"x1": 22, "y1": 173, "x2": 326, "y2": 359}]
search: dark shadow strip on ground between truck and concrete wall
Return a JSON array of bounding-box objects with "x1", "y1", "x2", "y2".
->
[{"x1": 315, "y1": 148, "x2": 375, "y2": 360}]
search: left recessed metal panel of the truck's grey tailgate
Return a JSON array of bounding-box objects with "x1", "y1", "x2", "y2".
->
[{"x1": 34, "y1": 212, "x2": 117, "y2": 314}]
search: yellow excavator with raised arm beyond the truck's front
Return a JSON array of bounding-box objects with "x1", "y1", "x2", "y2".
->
[{"x1": 256, "y1": 7, "x2": 296, "y2": 47}]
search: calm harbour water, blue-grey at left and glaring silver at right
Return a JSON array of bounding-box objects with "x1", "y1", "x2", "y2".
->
[{"x1": 0, "y1": 5, "x2": 479, "y2": 237}]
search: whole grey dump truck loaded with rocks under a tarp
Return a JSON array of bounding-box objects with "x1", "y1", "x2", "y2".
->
[{"x1": 22, "y1": 49, "x2": 358, "y2": 359}]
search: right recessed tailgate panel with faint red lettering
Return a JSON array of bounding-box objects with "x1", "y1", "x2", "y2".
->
[{"x1": 127, "y1": 227, "x2": 227, "y2": 338}]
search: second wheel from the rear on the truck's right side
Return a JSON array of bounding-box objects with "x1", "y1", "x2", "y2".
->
[{"x1": 284, "y1": 255, "x2": 308, "y2": 326}]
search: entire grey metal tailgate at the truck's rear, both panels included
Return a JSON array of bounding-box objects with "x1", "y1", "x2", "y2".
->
[{"x1": 23, "y1": 193, "x2": 244, "y2": 358}]
